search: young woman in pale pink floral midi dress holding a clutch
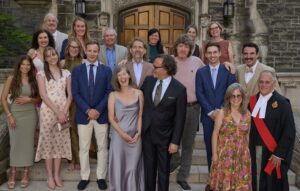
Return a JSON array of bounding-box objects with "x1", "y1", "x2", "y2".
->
[{"x1": 35, "y1": 47, "x2": 72, "y2": 189}]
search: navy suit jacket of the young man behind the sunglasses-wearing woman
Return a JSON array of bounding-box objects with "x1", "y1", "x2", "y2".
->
[{"x1": 196, "y1": 64, "x2": 236, "y2": 124}]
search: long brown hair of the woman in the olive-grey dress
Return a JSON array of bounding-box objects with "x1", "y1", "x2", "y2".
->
[{"x1": 9, "y1": 55, "x2": 39, "y2": 100}]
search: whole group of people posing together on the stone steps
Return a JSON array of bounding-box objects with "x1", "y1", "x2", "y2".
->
[{"x1": 1, "y1": 13, "x2": 295, "y2": 191}]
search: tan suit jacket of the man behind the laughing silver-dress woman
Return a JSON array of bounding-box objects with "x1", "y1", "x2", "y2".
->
[{"x1": 126, "y1": 61, "x2": 154, "y2": 89}]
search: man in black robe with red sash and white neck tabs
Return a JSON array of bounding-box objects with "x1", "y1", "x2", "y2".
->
[{"x1": 249, "y1": 70, "x2": 296, "y2": 191}]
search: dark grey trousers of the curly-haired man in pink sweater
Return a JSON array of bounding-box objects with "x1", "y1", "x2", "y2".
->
[{"x1": 171, "y1": 104, "x2": 200, "y2": 181}]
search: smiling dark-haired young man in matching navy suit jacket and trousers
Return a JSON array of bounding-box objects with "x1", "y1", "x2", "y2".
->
[{"x1": 196, "y1": 43, "x2": 236, "y2": 174}]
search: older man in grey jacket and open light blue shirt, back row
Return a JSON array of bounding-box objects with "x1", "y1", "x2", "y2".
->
[{"x1": 99, "y1": 28, "x2": 128, "y2": 71}]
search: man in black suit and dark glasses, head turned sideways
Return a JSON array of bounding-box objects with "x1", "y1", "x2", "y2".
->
[{"x1": 141, "y1": 55, "x2": 187, "y2": 191}]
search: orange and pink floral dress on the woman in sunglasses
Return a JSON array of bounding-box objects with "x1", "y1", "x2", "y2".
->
[{"x1": 208, "y1": 112, "x2": 252, "y2": 191}]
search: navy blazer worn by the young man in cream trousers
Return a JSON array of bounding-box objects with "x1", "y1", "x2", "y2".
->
[{"x1": 72, "y1": 63, "x2": 112, "y2": 124}]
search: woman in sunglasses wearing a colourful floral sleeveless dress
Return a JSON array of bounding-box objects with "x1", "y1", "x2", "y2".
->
[{"x1": 208, "y1": 83, "x2": 252, "y2": 191}]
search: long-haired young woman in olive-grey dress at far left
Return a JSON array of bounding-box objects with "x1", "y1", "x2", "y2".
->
[{"x1": 1, "y1": 56, "x2": 40, "y2": 189}]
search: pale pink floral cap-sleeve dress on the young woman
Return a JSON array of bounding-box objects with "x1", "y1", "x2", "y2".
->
[{"x1": 35, "y1": 70, "x2": 72, "y2": 162}]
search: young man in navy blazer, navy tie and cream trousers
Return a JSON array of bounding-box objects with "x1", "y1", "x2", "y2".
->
[{"x1": 72, "y1": 40, "x2": 112, "y2": 190}]
